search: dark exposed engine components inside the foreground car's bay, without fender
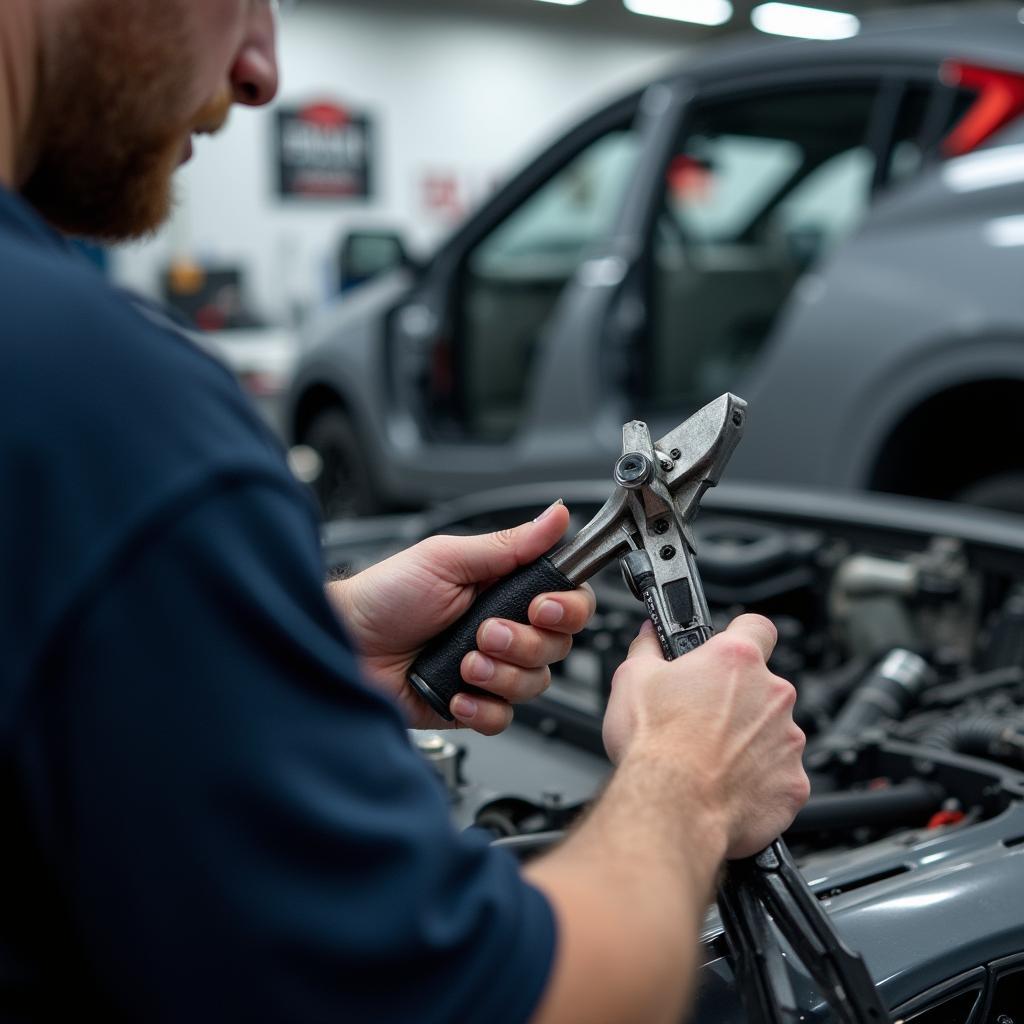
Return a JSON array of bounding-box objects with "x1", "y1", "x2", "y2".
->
[{"x1": 407, "y1": 496, "x2": 1024, "y2": 857}]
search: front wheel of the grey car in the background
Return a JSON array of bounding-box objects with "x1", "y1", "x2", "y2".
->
[{"x1": 304, "y1": 409, "x2": 380, "y2": 519}]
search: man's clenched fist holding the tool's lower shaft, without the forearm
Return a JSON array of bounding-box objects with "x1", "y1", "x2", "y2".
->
[{"x1": 604, "y1": 615, "x2": 810, "y2": 858}]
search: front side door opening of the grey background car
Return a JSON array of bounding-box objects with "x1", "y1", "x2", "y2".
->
[{"x1": 457, "y1": 126, "x2": 638, "y2": 440}]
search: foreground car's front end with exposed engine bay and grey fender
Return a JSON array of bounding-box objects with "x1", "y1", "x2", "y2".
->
[{"x1": 326, "y1": 483, "x2": 1024, "y2": 1024}]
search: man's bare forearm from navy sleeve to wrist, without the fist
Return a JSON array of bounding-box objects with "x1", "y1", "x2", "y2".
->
[{"x1": 525, "y1": 741, "x2": 727, "y2": 1024}]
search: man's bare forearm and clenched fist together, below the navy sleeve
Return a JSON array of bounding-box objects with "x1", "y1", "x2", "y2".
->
[{"x1": 526, "y1": 615, "x2": 808, "y2": 1024}]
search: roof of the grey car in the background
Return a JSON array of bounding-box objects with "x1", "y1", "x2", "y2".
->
[{"x1": 662, "y1": 3, "x2": 1024, "y2": 84}]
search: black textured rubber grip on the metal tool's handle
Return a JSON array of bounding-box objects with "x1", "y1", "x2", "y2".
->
[{"x1": 409, "y1": 557, "x2": 575, "y2": 722}]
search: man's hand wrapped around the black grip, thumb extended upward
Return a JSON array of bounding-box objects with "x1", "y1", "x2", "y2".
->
[{"x1": 328, "y1": 503, "x2": 595, "y2": 735}]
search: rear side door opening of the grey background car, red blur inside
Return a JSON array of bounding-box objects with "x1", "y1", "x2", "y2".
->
[{"x1": 643, "y1": 83, "x2": 877, "y2": 409}]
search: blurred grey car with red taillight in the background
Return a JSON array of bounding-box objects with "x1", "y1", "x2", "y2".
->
[{"x1": 287, "y1": 5, "x2": 1024, "y2": 516}]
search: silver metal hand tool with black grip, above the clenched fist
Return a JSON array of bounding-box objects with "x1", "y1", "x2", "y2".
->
[{"x1": 409, "y1": 394, "x2": 746, "y2": 721}]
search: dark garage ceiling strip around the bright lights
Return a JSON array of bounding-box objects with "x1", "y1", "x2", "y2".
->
[{"x1": 325, "y1": 0, "x2": 991, "y2": 44}]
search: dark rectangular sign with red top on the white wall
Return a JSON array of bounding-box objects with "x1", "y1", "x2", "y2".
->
[{"x1": 278, "y1": 102, "x2": 372, "y2": 199}]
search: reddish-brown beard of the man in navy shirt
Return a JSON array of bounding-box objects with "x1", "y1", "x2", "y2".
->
[{"x1": 20, "y1": 0, "x2": 231, "y2": 241}]
